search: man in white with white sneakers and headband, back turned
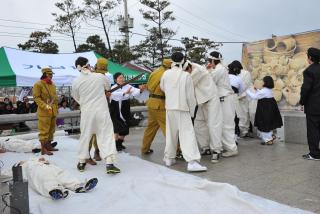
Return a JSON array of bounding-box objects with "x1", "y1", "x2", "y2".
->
[{"x1": 160, "y1": 52, "x2": 207, "y2": 172}]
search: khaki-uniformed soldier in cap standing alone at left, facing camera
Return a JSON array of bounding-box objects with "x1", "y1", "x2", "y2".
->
[{"x1": 32, "y1": 68, "x2": 58, "y2": 155}]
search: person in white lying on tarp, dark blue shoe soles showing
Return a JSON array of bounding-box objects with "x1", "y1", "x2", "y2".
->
[{"x1": 18, "y1": 157, "x2": 98, "y2": 200}]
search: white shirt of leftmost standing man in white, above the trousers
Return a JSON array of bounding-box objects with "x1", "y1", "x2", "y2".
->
[{"x1": 72, "y1": 72, "x2": 110, "y2": 112}]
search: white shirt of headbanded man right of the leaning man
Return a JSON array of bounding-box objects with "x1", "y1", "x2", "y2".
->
[{"x1": 209, "y1": 63, "x2": 234, "y2": 97}]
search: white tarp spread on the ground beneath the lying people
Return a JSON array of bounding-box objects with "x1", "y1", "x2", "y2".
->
[{"x1": 0, "y1": 136, "x2": 309, "y2": 214}]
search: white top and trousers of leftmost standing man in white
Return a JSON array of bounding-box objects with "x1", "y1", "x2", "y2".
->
[{"x1": 72, "y1": 71, "x2": 117, "y2": 164}]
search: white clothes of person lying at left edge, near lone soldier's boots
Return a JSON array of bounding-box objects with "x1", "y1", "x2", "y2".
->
[{"x1": 0, "y1": 138, "x2": 40, "y2": 153}]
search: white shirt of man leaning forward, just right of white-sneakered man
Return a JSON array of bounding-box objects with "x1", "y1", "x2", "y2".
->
[{"x1": 191, "y1": 63, "x2": 218, "y2": 104}]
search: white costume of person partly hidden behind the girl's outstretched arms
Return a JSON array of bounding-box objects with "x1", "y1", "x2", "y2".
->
[{"x1": 236, "y1": 69, "x2": 257, "y2": 136}]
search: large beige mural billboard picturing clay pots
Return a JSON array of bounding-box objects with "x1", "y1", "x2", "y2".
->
[{"x1": 242, "y1": 30, "x2": 320, "y2": 110}]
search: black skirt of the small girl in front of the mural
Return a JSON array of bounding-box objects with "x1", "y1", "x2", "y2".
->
[{"x1": 254, "y1": 98, "x2": 283, "y2": 132}]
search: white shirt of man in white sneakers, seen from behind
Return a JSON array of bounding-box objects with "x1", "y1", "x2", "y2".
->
[{"x1": 160, "y1": 66, "x2": 197, "y2": 117}]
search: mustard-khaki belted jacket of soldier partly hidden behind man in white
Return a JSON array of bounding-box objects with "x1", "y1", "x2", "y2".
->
[{"x1": 147, "y1": 66, "x2": 165, "y2": 110}]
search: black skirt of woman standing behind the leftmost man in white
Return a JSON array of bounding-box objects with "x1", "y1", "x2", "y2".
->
[{"x1": 110, "y1": 100, "x2": 131, "y2": 136}]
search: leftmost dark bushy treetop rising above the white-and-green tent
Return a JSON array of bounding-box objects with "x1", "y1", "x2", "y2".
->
[{"x1": 18, "y1": 31, "x2": 59, "y2": 53}]
